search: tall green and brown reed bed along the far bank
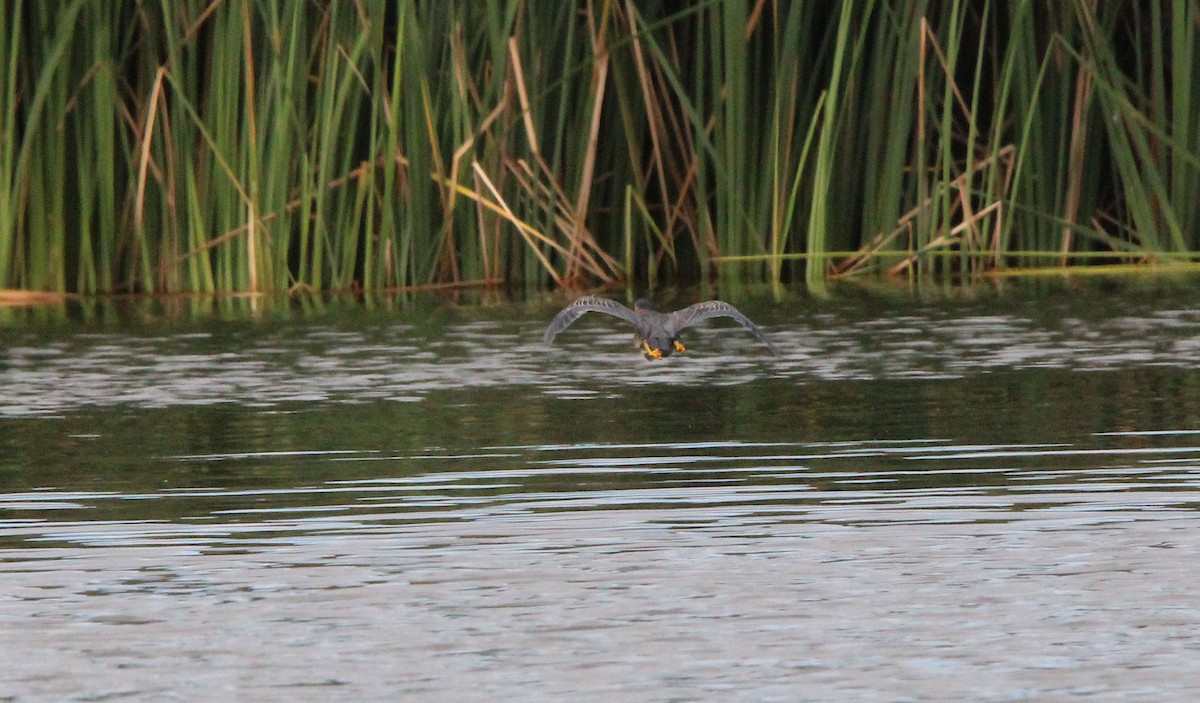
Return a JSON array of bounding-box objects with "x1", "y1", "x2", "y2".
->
[{"x1": 0, "y1": 0, "x2": 1200, "y2": 294}]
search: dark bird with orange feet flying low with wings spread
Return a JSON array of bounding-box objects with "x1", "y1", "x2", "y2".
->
[{"x1": 542, "y1": 295, "x2": 779, "y2": 361}]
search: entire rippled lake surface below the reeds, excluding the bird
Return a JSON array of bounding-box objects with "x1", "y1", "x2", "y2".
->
[{"x1": 0, "y1": 283, "x2": 1200, "y2": 702}]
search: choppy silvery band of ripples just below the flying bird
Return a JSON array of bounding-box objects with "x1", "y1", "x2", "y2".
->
[{"x1": 7, "y1": 293, "x2": 1200, "y2": 416}]
